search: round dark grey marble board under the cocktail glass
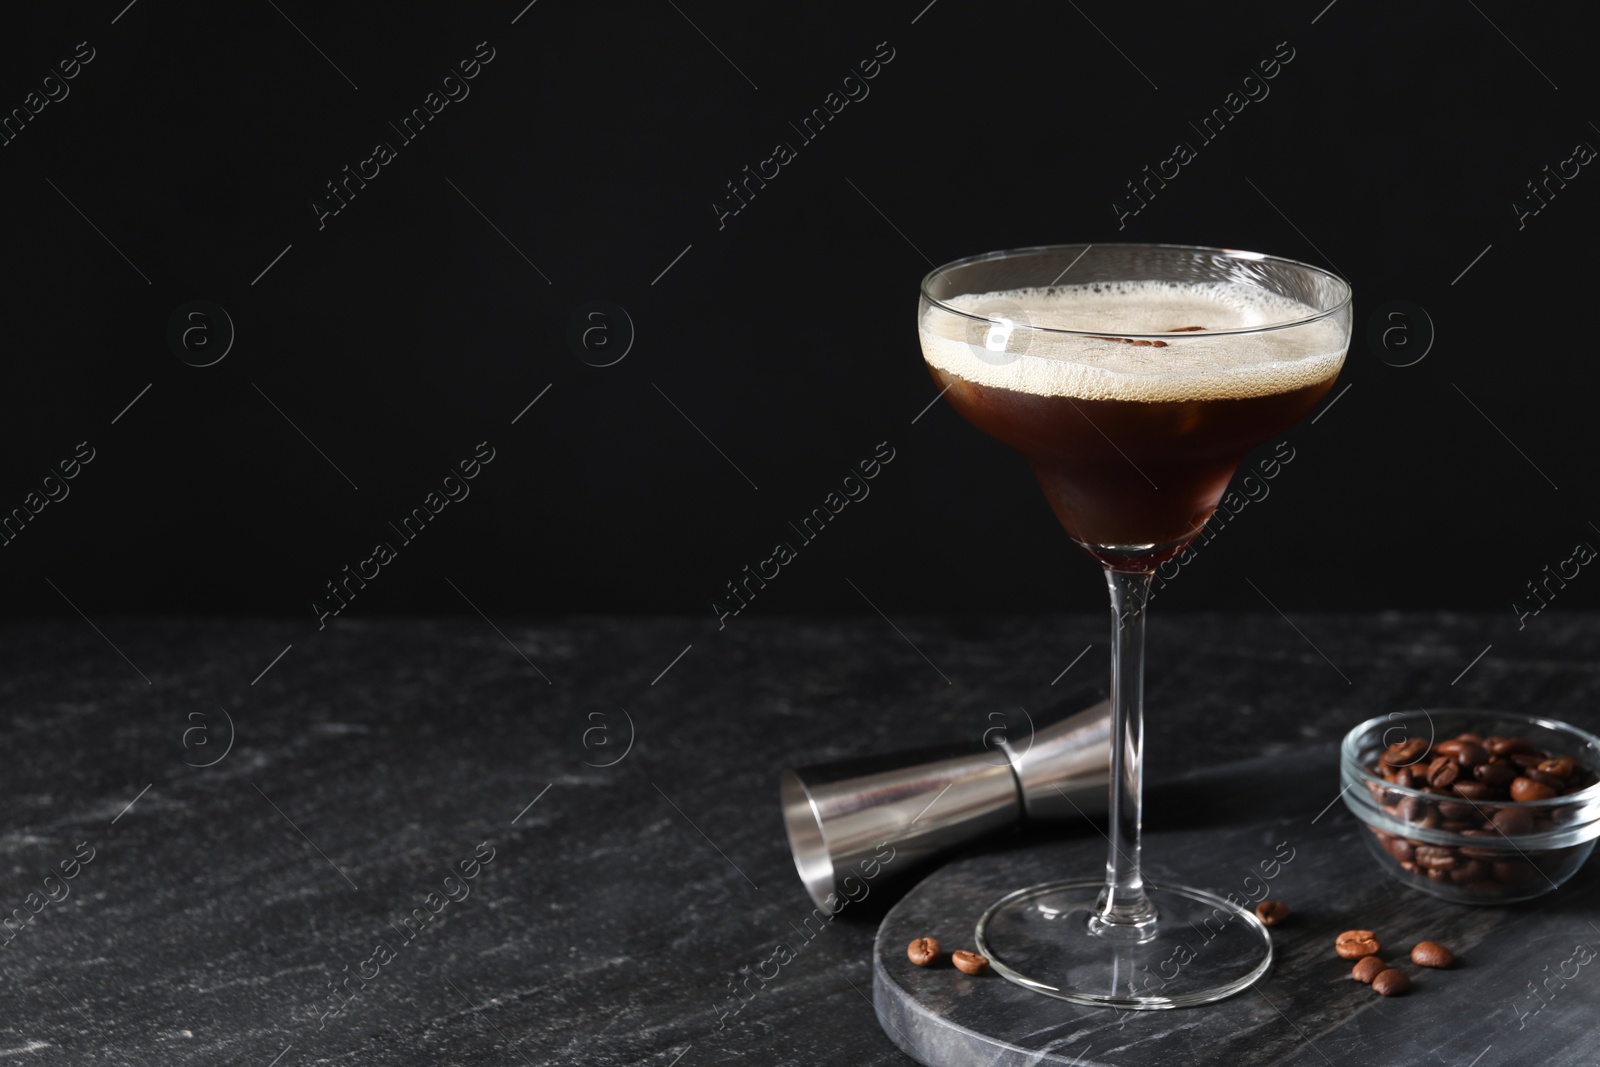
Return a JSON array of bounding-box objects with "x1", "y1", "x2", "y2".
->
[{"x1": 874, "y1": 760, "x2": 1600, "y2": 1067}]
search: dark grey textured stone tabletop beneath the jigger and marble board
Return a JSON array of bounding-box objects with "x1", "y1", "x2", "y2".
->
[{"x1": 0, "y1": 611, "x2": 1600, "y2": 1067}]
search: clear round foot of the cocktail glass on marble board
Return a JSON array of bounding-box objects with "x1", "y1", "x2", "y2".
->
[{"x1": 978, "y1": 880, "x2": 1272, "y2": 1011}]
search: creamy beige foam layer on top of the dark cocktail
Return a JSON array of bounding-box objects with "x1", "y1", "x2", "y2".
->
[{"x1": 918, "y1": 282, "x2": 1346, "y2": 402}]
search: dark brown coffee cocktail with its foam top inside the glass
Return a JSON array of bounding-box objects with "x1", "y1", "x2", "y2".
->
[{"x1": 922, "y1": 283, "x2": 1344, "y2": 569}]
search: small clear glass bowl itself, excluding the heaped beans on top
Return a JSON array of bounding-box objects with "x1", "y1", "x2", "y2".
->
[{"x1": 1339, "y1": 709, "x2": 1600, "y2": 904}]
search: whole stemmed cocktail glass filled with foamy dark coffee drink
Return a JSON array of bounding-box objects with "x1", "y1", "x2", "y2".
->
[{"x1": 917, "y1": 245, "x2": 1350, "y2": 1009}]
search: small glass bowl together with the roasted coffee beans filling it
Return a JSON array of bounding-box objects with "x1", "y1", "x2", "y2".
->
[{"x1": 1339, "y1": 709, "x2": 1600, "y2": 904}]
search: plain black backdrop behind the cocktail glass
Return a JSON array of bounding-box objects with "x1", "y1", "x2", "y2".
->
[{"x1": 0, "y1": 0, "x2": 1600, "y2": 630}]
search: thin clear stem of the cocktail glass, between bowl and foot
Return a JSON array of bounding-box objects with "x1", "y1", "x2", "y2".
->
[{"x1": 1090, "y1": 568, "x2": 1155, "y2": 941}]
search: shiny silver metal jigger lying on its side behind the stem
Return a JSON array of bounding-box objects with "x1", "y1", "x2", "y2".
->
[{"x1": 779, "y1": 693, "x2": 1110, "y2": 907}]
